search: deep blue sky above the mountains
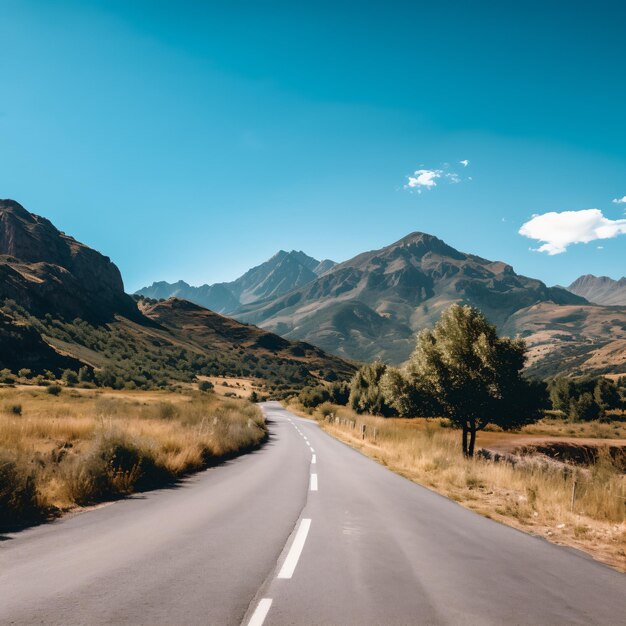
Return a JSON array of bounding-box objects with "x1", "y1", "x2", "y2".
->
[{"x1": 0, "y1": 0, "x2": 626, "y2": 290}]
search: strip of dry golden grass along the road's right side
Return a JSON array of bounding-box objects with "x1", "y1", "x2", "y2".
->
[{"x1": 308, "y1": 407, "x2": 626, "y2": 571}]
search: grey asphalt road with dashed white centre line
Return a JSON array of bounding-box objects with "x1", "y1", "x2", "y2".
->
[{"x1": 0, "y1": 403, "x2": 626, "y2": 626}]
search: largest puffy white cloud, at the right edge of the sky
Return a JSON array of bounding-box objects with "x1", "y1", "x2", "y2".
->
[{"x1": 519, "y1": 209, "x2": 626, "y2": 255}]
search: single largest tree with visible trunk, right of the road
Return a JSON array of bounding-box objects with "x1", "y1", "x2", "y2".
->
[{"x1": 409, "y1": 304, "x2": 545, "y2": 457}]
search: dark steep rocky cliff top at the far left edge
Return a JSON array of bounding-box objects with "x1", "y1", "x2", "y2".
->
[{"x1": 0, "y1": 200, "x2": 138, "y2": 322}]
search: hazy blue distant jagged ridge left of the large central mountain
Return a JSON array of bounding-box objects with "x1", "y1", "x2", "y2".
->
[{"x1": 136, "y1": 250, "x2": 335, "y2": 314}]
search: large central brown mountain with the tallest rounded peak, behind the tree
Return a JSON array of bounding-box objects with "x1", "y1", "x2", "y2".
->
[{"x1": 235, "y1": 233, "x2": 587, "y2": 363}]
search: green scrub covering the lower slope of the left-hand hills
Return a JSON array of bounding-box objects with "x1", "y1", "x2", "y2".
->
[{"x1": 0, "y1": 300, "x2": 348, "y2": 399}]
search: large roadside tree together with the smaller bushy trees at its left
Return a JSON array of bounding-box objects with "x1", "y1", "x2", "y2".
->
[{"x1": 350, "y1": 304, "x2": 546, "y2": 457}]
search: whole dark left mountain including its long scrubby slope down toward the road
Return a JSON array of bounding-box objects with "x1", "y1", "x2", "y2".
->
[{"x1": 0, "y1": 200, "x2": 354, "y2": 393}]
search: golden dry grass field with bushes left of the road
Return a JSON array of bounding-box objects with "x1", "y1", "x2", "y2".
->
[{"x1": 0, "y1": 385, "x2": 267, "y2": 530}]
